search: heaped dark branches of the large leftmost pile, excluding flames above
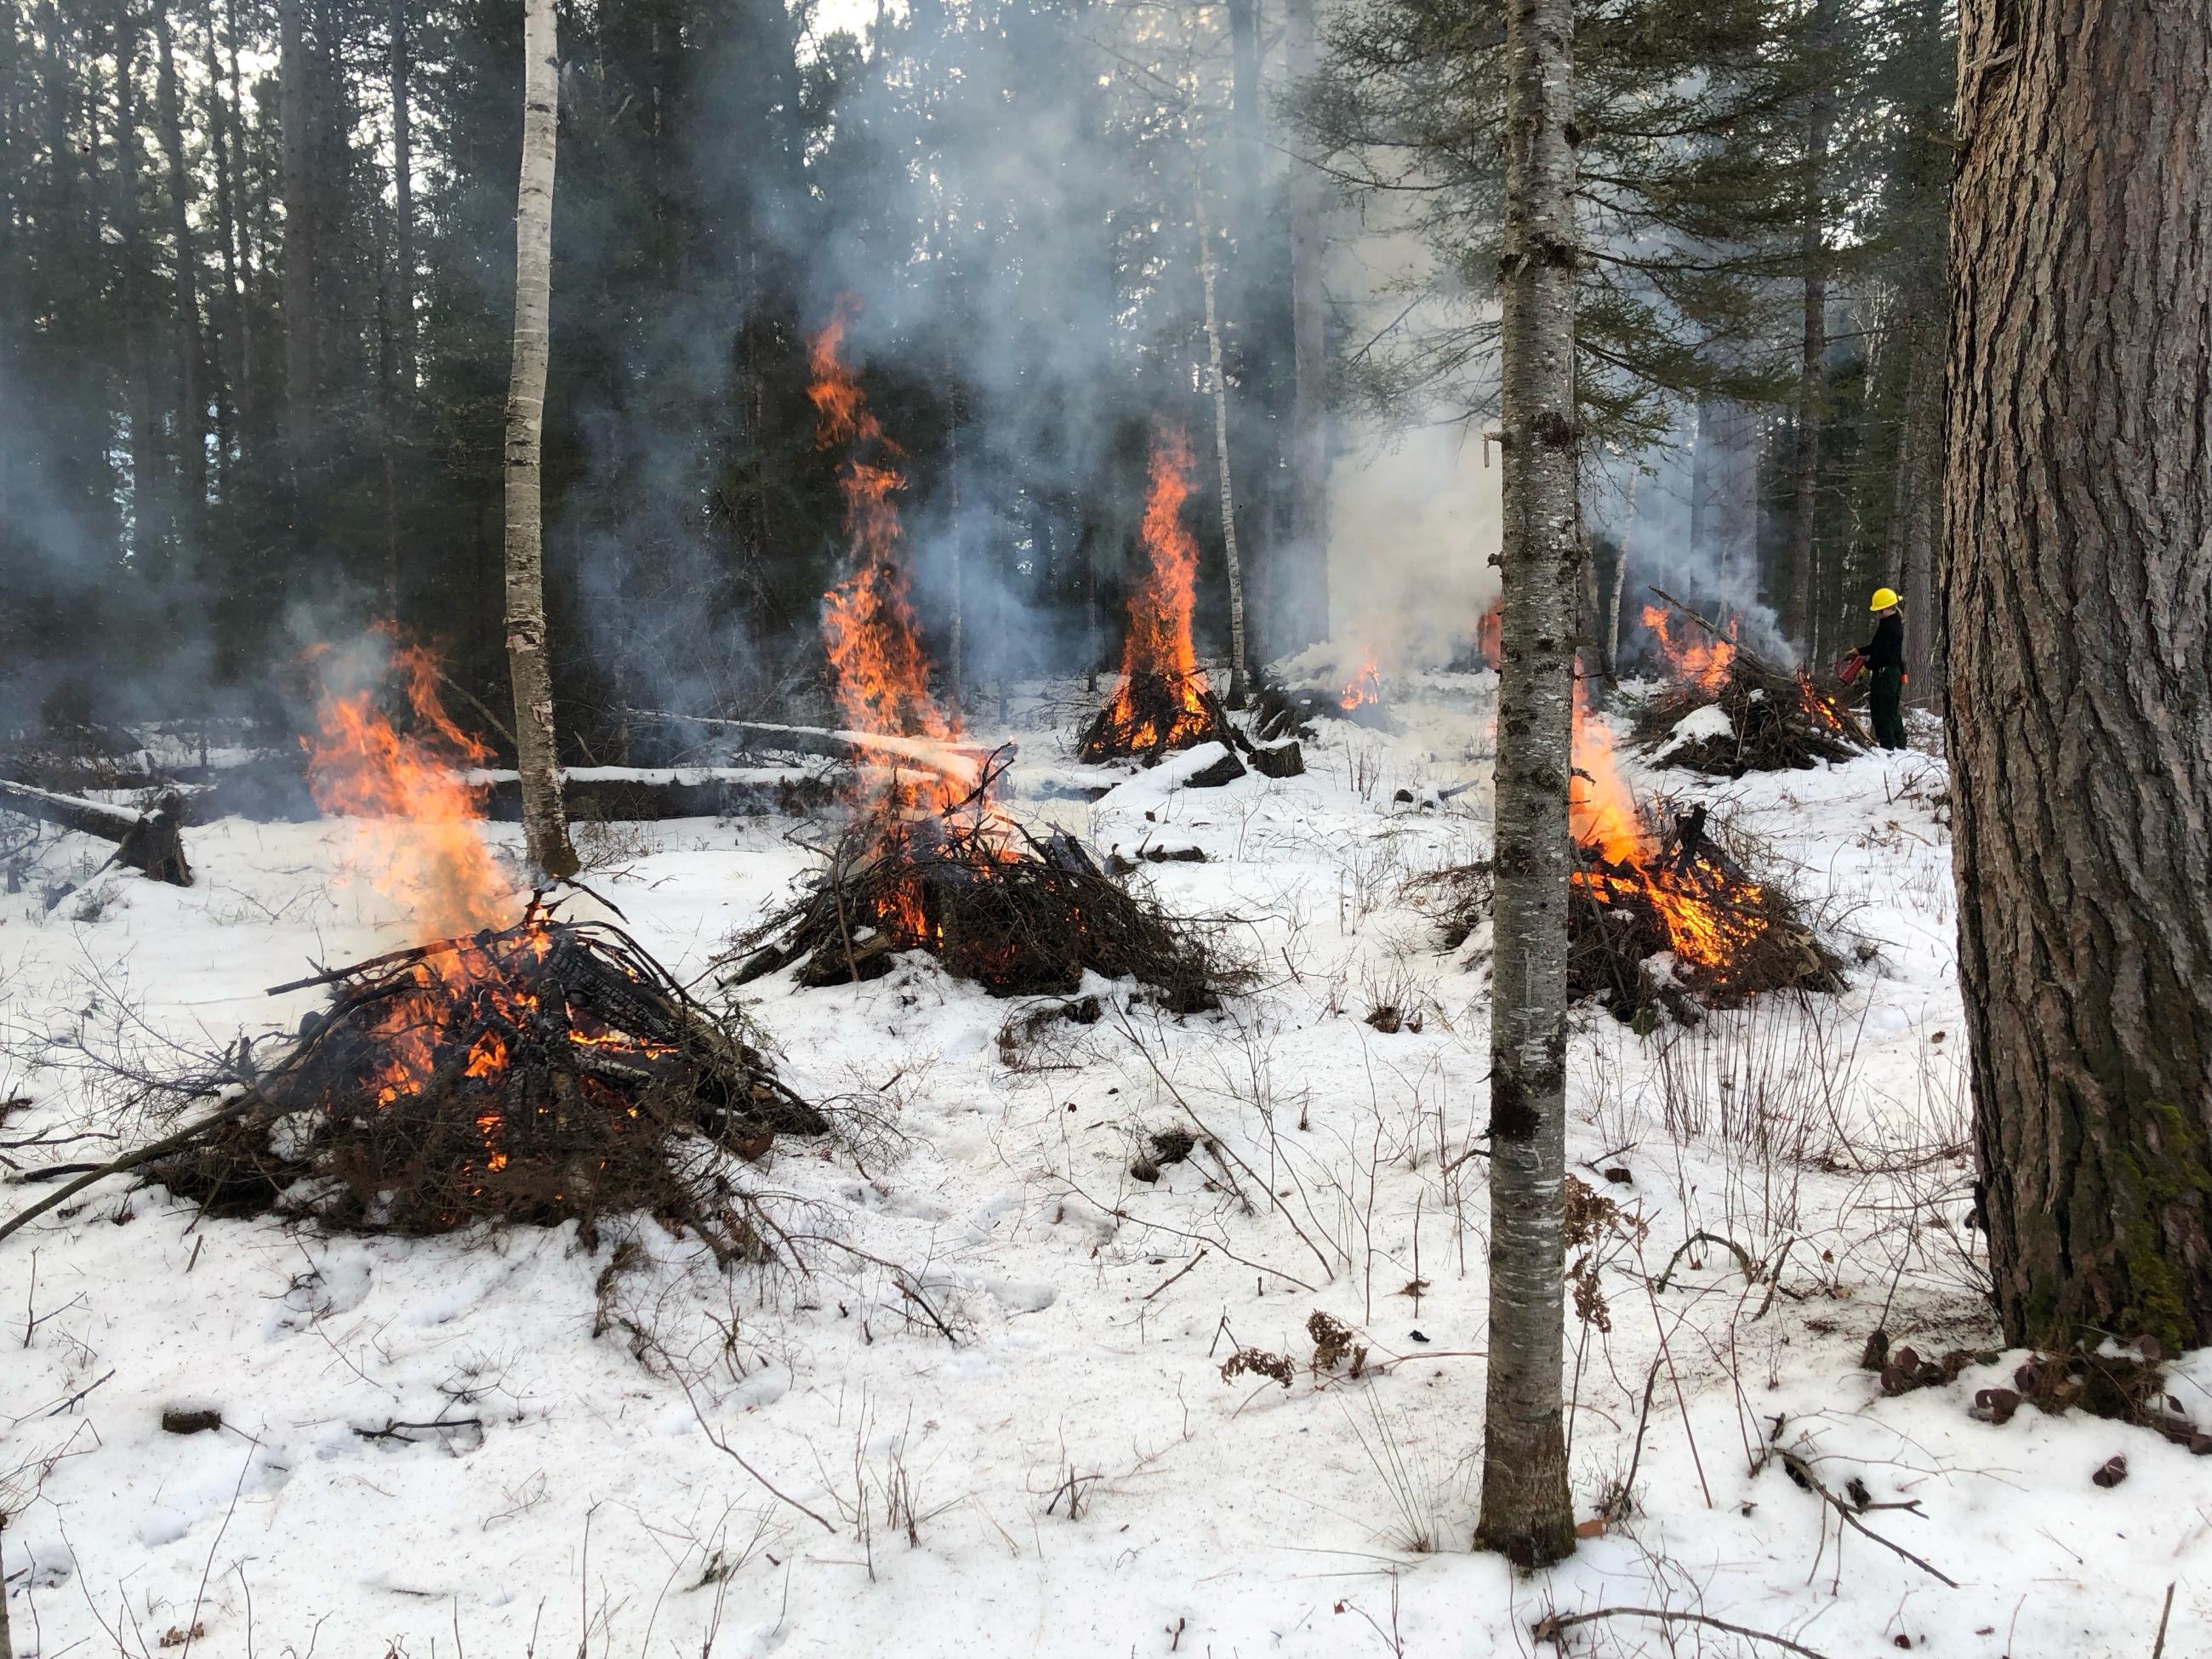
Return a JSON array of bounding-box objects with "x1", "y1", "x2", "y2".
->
[{"x1": 151, "y1": 904, "x2": 830, "y2": 1261}]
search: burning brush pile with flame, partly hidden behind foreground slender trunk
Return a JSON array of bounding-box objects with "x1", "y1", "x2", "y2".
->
[{"x1": 1422, "y1": 699, "x2": 1843, "y2": 1024}]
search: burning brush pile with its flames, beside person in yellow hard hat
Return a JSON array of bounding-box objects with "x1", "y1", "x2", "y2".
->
[{"x1": 1634, "y1": 595, "x2": 1869, "y2": 778}]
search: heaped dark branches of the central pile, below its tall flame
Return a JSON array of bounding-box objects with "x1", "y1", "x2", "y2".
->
[{"x1": 726, "y1": 810, "x2": 1234, "y2": 1013}]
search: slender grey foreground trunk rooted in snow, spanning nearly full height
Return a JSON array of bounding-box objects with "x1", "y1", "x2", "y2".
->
[{"x1": 1468, "y1": 0, "x2": 1582, "y2": 1566}]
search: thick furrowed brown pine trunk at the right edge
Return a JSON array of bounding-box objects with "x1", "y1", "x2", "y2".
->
[{"x1": 1944, "y1": 0, "x2": 2212, "y2": 1345}]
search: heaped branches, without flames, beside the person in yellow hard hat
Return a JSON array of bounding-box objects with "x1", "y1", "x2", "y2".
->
[{"x1": 1634, "y1": 589, "x2": 1872, "y2": 778}]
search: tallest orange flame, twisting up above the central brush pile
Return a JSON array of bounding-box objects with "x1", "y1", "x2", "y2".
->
[{"x1": 807, "y1": 301, "x2": 960, "y2": 751}]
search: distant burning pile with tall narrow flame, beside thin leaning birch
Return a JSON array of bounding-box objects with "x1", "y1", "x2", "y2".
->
[{"x1": 1081, "y1": 423, "x2": 1223, "y2": 761}]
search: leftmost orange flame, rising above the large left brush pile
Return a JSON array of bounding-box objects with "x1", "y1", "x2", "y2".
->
[{"x1": 307, "y1": 630, "x2": 513, "y2": 940}]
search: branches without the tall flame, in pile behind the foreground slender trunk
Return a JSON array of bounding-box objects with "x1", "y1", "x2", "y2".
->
[{"x1": 1420, "y1": 807, "x2": 1843, "y2": 1024}]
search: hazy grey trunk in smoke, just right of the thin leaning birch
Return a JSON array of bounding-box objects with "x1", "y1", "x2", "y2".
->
[{"x1": 1276, "y1": 0, "x2": 1330, "y2": 650}]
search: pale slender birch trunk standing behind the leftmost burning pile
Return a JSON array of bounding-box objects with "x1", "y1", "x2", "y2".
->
[{"x1": 506, "y1": 0, "x2": 578, "y2": 878}]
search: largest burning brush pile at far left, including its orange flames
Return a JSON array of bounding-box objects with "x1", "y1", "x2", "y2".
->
[{"x1": 155, "y1": 650, "x2": 827, "y2": 1258}]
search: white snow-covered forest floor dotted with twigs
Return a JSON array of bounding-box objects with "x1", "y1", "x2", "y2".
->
[{"x1": 0, "y1": 675, "x2": 2212, "y2": 1659}]
